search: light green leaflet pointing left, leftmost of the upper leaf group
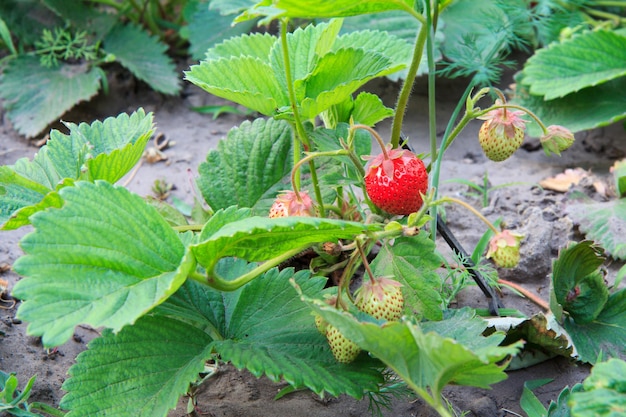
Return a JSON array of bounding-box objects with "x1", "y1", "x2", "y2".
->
[{"x1": 185, "y1": 56, "x2": 289, "y2": 116}]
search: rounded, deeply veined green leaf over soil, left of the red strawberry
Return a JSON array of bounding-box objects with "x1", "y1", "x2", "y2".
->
[{"x1": 198, "y1": 119, "x2": 292, "y2": 211}]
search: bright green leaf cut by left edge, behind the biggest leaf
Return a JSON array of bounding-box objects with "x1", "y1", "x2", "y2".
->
[{"x1": 0, "y1": 109, "x2": 153, "y2": 229}]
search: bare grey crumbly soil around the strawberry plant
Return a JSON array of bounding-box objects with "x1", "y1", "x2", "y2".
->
[{"x1": 0, "y1": 66, "x2": 626, "y2": 417}]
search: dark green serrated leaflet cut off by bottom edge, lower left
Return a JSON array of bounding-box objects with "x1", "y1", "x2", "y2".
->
[{"x1": 61, "y1": 316, "x2": 212, "y2": 417}]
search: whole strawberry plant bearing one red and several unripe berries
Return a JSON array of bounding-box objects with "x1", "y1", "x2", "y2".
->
[{"x1": 0, "y1": 0, "x2": 624, "y2": 417}]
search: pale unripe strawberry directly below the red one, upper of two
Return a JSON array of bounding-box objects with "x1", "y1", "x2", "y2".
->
[{"x1": 355, "y1": 277, "x2": 404, "y2": 321}]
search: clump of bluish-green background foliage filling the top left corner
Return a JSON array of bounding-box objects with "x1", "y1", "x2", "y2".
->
[{"x1": 0, "y1": 0, "x2": 254, "y2": 137}]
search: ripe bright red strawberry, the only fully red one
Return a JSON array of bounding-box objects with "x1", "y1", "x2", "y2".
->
[{"x1": 365, "y1": 145, "x2": 428, "y2": 215}]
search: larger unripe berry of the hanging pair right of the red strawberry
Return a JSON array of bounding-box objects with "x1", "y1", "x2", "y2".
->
[{"x1": 478, "y1": 103, "x2": 526, "y2": 162}]
